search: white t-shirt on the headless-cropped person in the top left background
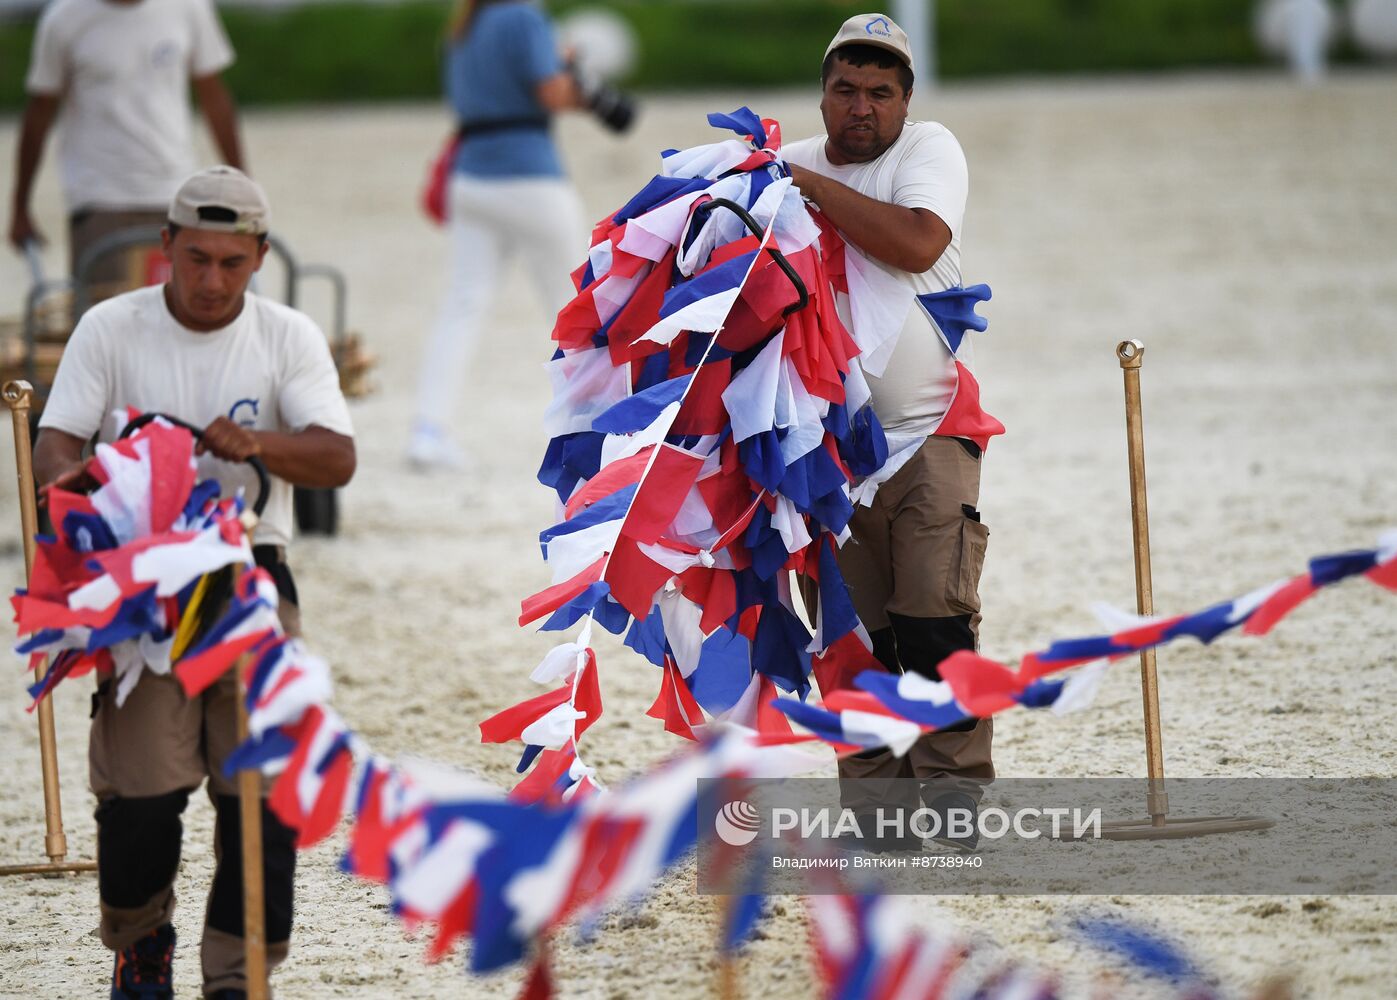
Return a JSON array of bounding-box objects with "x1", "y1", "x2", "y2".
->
[{"x1": 25, "y1": 0, "x2": 233, "y2": 211}]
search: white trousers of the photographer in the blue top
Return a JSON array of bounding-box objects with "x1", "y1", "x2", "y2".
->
[{"x1": 418, "y1": 173, "x2": 587, "y2": 430}]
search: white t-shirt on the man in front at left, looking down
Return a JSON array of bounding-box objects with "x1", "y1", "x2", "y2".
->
[{"x1": 39, "y1": 285, "x2": 353, "y2": 545}]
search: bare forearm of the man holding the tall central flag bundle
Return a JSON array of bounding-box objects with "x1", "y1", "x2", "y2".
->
[{"x1": 791, "y1": 166, "x2": 951, "y2": 274}]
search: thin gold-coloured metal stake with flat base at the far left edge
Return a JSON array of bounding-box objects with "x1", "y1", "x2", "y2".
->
[{"x1": 0, "y1": 380, "x2": 96, "y2": 876}]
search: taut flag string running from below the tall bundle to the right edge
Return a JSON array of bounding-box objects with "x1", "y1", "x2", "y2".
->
[{"x1": 773, "y1": 531, "x2": 1397, "y2": 756}]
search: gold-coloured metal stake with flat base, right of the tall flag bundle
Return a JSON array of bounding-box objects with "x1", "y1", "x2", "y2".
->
[{"x1": 1101, "y1": 341, "x2": 1275, "y2": 841}]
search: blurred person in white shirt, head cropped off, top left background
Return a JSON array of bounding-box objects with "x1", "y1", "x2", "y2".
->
[{"x1": 8, "y1": 0, "x2": 244, "y2": 293}]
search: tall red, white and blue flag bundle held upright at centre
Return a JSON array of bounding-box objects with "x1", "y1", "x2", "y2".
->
[{"x1": 481, "y1": 108, "x2": 1003, "y2": 796}]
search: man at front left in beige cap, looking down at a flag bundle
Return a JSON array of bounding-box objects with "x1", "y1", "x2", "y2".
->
[{"x1": 34, "y1": 166, "x2": 355, "y2": 997}]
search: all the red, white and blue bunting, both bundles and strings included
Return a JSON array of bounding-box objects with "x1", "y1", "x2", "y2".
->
[{"x1": 13, "y1": 109, "x2": 1397, "y2": 997}]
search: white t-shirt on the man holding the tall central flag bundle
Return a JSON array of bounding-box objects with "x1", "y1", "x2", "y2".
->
[{"x1": 781, "y1": 122, "x2": 972, "y2": 434}]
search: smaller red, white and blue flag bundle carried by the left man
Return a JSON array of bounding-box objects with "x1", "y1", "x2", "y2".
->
[{"x1": 11, "y1": 420, "x2": 275, "y2": 708}]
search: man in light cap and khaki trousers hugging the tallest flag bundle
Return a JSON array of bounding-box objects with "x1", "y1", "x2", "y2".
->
[{"x1": 782, "y1": 13, "x2": 995, "y2": 849}]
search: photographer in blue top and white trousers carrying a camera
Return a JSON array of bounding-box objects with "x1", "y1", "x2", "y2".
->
[{"x1": 408, "y1": 0, "x2": 633, "y2": 471}]
